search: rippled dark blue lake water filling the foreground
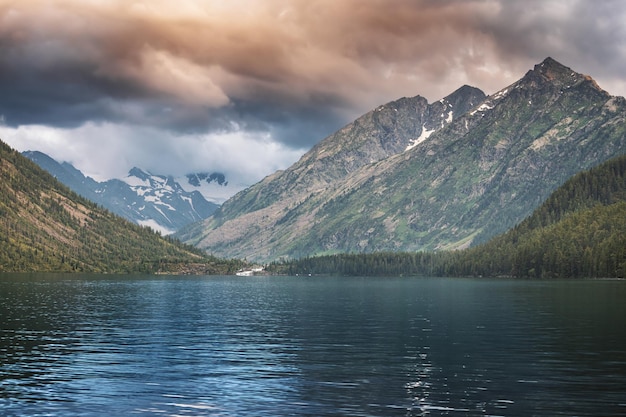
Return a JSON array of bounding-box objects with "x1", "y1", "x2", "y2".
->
[{"x1": 0, "y1": 275, "x2": 626, "y2": 416}]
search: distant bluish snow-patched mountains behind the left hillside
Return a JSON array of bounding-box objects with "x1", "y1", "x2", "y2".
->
[{"x1": 23, "y1": 151, "x2": 218, "y2": 234}]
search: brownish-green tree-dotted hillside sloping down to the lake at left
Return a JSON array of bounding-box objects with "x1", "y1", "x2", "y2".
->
[{"x1": 0, "y1": 141, "x2": 242, "y2": 274}]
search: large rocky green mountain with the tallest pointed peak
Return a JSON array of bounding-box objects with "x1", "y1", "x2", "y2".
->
[{"x1": 177, "y1": 58, "x2": 626, "y2": 261}]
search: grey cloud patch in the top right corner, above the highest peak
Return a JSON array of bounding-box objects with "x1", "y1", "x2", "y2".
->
[{"x1": 483, "y1": 0, "x2": 626, "y2": 79}]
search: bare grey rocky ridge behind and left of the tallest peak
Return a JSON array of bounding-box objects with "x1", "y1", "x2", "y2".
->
[{"x1": 207, "y1": 86, "x2": 485, "y2": 219}]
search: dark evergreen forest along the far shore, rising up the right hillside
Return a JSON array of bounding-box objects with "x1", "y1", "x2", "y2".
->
[{"x1": 269, "y1": 156, "x2": 626, "y2": 278}]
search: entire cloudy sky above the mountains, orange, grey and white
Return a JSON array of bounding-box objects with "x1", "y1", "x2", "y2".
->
[{"x1": 0, "y1": 0, "x2": 626, "y2": 185}]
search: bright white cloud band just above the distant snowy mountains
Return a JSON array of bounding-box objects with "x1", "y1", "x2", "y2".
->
[{"x1": 0, "y1": 123, "x2": 305, "y2": 185}]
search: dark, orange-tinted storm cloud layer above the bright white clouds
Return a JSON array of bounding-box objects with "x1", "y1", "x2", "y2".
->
[{"x1": 0, "y1": 0, "x2": 624, "y2": 141}]
